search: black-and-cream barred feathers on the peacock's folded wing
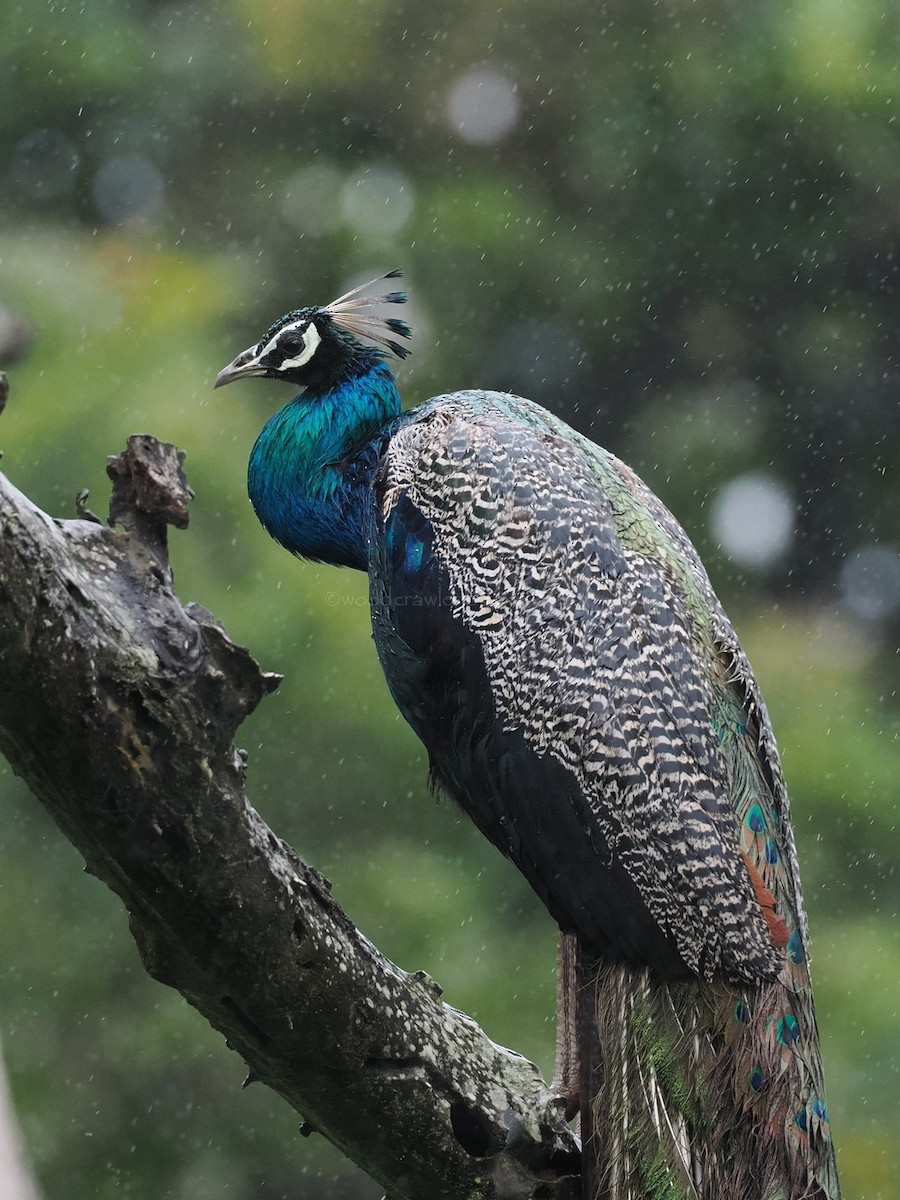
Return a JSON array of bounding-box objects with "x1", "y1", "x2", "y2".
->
[{"x1": 373, "y1": 392, "x2": 778, "y2": 979}]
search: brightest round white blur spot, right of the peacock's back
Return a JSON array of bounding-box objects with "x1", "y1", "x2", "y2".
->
[{"x1": 712, "y1": 473, "x2": 793, "y2": 569}]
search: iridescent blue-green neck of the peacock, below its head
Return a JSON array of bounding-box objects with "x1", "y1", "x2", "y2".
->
[{"x1": 247, "y1": 361, "x2": 400, "y2": 571}]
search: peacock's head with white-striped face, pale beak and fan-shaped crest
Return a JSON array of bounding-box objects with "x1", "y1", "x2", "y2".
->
[{"x1": 215, "y1": 271, "x2": 412, "y2": 390}]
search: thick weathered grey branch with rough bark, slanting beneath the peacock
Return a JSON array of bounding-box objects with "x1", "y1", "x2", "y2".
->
[{"x1": 0, "y1": 400, "x2": 578, "y2": 1200}]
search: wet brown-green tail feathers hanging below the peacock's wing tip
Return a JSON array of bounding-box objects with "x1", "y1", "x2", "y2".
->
[{"x1": 586, "y1": 962, "x2": 840, "y2": 1200}]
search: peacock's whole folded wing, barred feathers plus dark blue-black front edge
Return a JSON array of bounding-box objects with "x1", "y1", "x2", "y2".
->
[{"x1": 371, "y1": 392, "x2": 778, "y2": 979}]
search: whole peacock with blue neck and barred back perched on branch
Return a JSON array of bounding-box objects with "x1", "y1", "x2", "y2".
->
[{"x1": 216, "y1": 271, "x2": 840, "y2": 1200}]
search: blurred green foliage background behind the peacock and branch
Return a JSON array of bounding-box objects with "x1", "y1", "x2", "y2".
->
[{"x1": 0, "y1": 0, "x2": 900, "y2": 1200}]
